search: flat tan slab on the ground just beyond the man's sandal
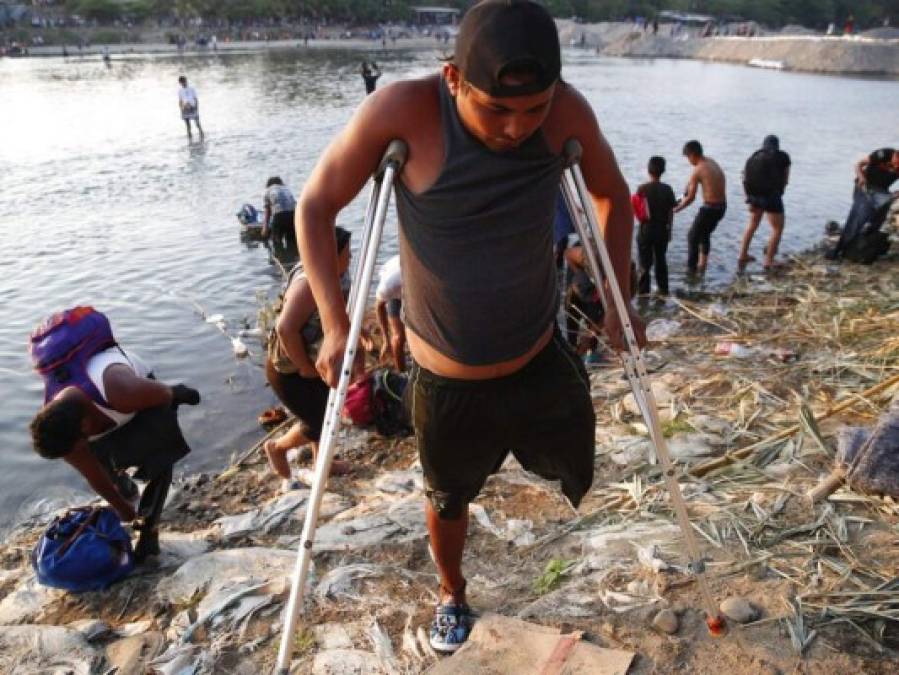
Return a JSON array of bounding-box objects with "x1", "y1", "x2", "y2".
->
[{"x1": 427, "y1": 614, "x2": 634, "y2": 675}]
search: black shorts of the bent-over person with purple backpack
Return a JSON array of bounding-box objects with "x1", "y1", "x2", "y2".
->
[{"x1": 88, "y1": 406, "x2": 190, "y2": 481}]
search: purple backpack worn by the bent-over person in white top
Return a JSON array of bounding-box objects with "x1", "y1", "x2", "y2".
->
[{"x1": 29, "y1": 307, "x2": 116, "y2": 406}]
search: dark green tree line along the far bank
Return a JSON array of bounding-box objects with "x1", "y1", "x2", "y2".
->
[{"x1": 58, "y1": 0, "x2": 899, "y2": 28}]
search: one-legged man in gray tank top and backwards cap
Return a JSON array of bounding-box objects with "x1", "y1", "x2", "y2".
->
[{"x1": 287, "y1": 0, "x2": 645, "y2": 652}]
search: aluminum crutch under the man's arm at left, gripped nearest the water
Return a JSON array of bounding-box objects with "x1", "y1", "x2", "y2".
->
[{"x1": 275, "y1": 140, "x2": 407, "y2": 675}]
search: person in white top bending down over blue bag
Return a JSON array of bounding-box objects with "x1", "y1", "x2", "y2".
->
[{"x1": 31, "y1": 308, "x2": 200, "y2": 562}]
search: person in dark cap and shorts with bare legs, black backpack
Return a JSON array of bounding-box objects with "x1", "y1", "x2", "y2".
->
[{"x1": 737, "y1": 136, "x2": 791, "y2": 271}]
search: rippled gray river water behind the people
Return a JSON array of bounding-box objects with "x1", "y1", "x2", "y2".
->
[{"x1": 0, "y1": 50, "x2": 899, "y2": 525}]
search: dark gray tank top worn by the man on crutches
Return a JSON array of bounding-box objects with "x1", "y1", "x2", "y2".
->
[{"x1": 396, "y1": 79, "x2": 562, "y2": 366}]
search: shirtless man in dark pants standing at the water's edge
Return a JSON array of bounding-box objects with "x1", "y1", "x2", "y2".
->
[{"x1": 674, "y1": 141, "x2": 727, "y2": 274}]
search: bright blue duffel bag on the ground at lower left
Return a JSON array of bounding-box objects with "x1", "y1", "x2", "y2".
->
[{"x1": 31, "y1": 506, "x2": 134, "y2": 593}]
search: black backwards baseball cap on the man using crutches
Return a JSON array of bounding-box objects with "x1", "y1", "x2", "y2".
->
[{"x1": 453, "y1": 0, "x2": 562, "y2": 97}]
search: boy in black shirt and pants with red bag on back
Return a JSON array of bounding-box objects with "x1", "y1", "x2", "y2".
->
[{"x1": 637, "y1": 157, "x2": 677, "y2": 295}]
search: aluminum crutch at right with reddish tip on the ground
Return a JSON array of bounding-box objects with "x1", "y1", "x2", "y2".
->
[{"x1": 562, "y1": 138, "x2": 726, "y2": 636}]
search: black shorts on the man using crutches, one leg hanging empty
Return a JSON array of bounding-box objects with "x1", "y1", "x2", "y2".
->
[{"x1": 407, "y1": 332, "x2": 596, "y2": 519}]
